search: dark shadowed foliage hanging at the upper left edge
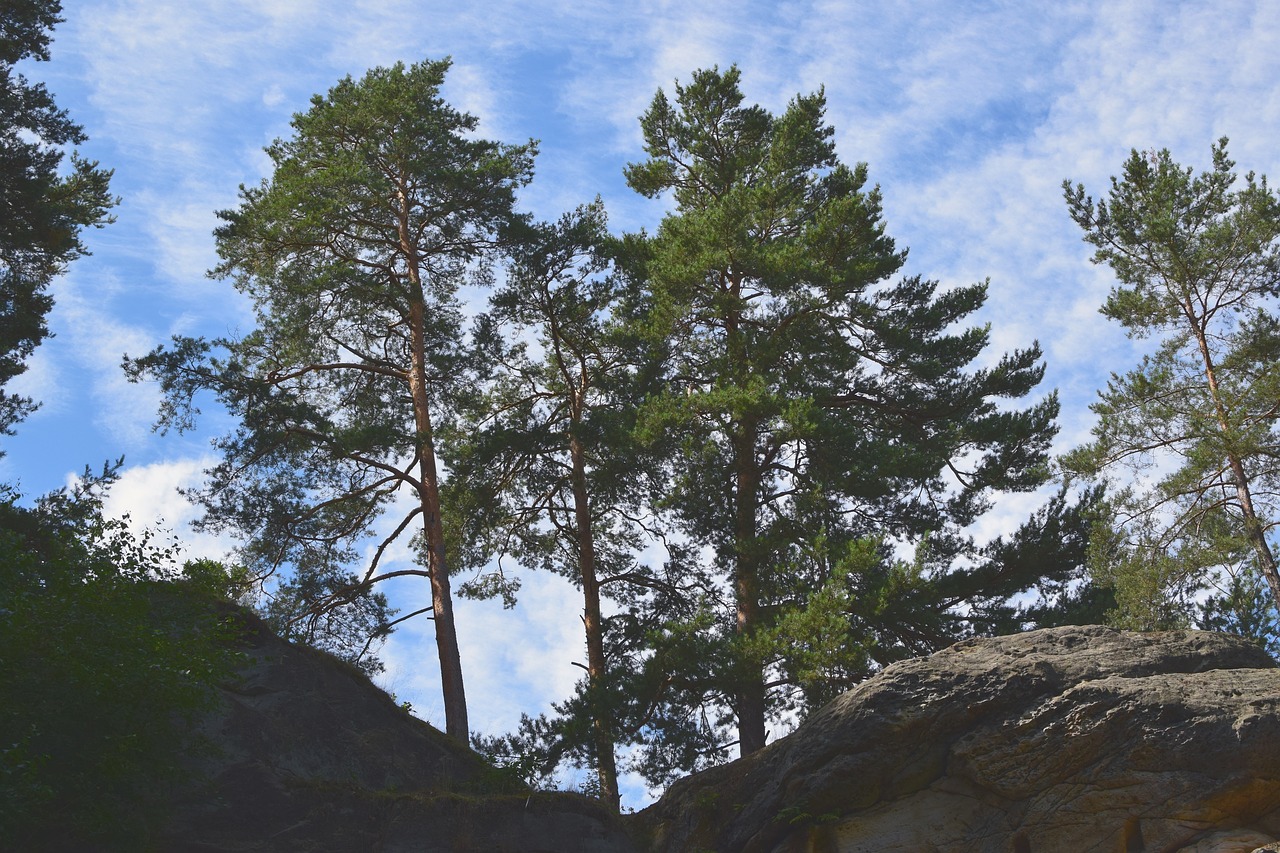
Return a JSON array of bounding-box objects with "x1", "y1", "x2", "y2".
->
[{"x1": 0, "y1": 0, "x2": 115, "y2": 433}]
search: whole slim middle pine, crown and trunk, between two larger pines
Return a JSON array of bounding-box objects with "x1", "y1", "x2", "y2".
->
[{"x1": 447, "y1": 201, "x2": 658, "y2": 809}]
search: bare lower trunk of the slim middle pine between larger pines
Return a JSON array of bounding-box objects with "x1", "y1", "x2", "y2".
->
[{"x1": 570, "y1": 423, "x2": 622, "y2": 811}]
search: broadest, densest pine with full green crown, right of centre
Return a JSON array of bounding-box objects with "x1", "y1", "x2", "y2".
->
[{"x1": 481, "y1": 69, "x2": 1100, "y2": 785}]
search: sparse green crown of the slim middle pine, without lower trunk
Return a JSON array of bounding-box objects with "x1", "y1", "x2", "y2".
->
[{"x1": 443, "y1": 201, "x2": 644, "y2": 594}]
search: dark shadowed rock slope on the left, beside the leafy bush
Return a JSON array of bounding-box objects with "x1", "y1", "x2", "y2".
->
[{"x1": 154, "y1": 615, "x2": 636, "y2": 853}]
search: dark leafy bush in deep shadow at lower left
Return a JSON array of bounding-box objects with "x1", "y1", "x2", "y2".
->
[{"x1": 0, "y1": 469, "x2": 236, "y2": 850}]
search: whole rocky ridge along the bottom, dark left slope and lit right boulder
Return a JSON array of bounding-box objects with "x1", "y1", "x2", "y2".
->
[{"x1": 159, "y1": 621, "x2": 1280, "y2": 853}]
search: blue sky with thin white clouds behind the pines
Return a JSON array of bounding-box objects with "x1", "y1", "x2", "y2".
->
[{"x1": 10, "y1": 0, "x2": 1280, "y2": 804}]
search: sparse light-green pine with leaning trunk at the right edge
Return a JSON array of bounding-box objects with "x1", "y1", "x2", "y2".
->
[{"x1": 1062, "y1": 138, "x2": 1280, "y2": 630}]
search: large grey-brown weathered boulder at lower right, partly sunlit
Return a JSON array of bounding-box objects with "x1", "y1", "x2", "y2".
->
[{"x1": 635, "y1": 626, "x2": 1280, "y2": 853}]
